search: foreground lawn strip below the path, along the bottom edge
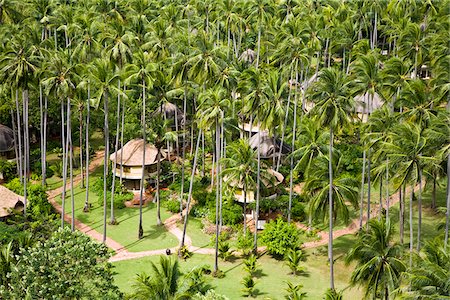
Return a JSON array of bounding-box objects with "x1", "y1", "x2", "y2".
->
[{"x1": 113, "y1": 248, "x2": 362, "y2": 299}]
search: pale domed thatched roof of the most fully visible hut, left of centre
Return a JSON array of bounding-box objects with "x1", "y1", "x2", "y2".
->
[{"x1": 109, "y1": 139, "x2": 165, "y2": 167}]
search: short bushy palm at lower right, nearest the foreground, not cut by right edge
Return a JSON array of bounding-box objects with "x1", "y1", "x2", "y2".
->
[{"x1": 345, "y1": 219, "x2": 406, "y2": 299}]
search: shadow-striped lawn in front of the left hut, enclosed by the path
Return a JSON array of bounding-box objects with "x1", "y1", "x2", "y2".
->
[{"x1": 59, "y1": 187, "x2": 178, "y2": 252}]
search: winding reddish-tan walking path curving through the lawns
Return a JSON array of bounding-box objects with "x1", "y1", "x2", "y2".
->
[{"x1": 47, "y1": 151, "x2": 418, "y2": 262}]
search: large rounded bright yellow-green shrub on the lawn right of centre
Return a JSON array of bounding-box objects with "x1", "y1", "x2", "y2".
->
[{"x1": 261, "y1": 218, "x2": 300, "y2": 256}]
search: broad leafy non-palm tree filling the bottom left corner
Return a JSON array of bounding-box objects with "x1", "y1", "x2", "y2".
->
[{"x1": 0, "y1": 228, "x2": 121, "y2": 299}]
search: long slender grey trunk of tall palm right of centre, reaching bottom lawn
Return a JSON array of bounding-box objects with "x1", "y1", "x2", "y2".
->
[{"x1": 328, "y1": 126, "x2": 334, "y2": 290}]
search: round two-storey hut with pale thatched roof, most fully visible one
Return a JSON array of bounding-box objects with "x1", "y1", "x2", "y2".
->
[{"x1": 109, "y1": 139, "x2": 166, "y2": 190}]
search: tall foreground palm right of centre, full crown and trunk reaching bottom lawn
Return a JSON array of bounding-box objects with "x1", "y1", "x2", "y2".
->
[{"x1": 311, "y1": 68, "x2": 353, "y2": 290}]
